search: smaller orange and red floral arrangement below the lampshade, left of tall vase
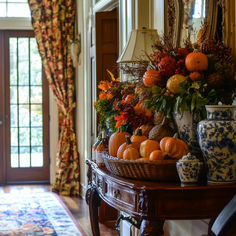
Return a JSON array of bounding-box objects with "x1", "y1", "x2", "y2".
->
[{"x1": 94, "y1": 70, "x2": 152, "y2": 133}]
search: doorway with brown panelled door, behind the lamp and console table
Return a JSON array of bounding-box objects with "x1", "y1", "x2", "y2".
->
[{"x1": 90, "y1": 8, "x2": 119, "y2": 228}]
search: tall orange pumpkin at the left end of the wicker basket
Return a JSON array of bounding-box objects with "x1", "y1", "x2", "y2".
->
[{"x1": 108, "y1": 131, "x2": 130, "y2": 157}]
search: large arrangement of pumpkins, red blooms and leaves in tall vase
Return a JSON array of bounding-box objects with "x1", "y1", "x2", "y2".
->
[{"x1": 144, "y1": 39, "x2": 236, "y2": 119}]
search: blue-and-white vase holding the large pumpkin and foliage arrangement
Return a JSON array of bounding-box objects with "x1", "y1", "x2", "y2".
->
[{"x1": 173, "y1": 111, "x2": 201, "y2": 156}]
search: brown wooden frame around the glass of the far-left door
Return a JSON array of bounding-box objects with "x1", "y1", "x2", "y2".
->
[{"x1": 0, "y1": 30, "x2": 50, "y2": 184}]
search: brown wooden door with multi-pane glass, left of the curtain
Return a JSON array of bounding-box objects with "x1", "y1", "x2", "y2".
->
[{"x1": 0, "y1": 31, "x2": 49, "y2": 183}]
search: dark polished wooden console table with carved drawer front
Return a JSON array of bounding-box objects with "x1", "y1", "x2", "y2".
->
[{"x1": 86, "y1": 161, "x2": 236, "y2": 236}]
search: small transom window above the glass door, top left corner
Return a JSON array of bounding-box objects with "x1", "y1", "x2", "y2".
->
[{"x1": 0, "y1": 0, "x2": 30, "y2": 17}]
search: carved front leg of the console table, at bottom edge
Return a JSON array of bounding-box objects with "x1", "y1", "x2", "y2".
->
[{"x1": 139, "y1": 220, "x2": 164, "y2": 236}]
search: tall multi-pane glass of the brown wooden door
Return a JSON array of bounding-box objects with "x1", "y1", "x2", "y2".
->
[{"x1": 9, "y1": 37, "x2": 43, "y2": 168}]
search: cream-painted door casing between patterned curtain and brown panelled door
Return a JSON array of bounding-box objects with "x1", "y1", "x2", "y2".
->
[{"x1": 79, "y1": 0, "x2": 119, "y2": 197}]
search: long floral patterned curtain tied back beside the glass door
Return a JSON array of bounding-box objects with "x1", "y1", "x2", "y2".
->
[{"x1": 28, "y1": 0, "x2": 79, "y2": 196}]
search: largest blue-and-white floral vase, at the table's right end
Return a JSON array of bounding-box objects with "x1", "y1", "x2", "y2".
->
[{"x1": 197, "y1": 105, "x2": 236, "y2": 184}]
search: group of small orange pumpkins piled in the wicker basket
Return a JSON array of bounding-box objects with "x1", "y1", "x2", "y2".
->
[{"x1": 109, "y1": 126, "x2": 188, "y2": 161}]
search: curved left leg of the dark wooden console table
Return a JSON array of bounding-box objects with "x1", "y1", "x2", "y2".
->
[{"x1": 86, "y1": 186, "x2": 101, "y2": 236}]
